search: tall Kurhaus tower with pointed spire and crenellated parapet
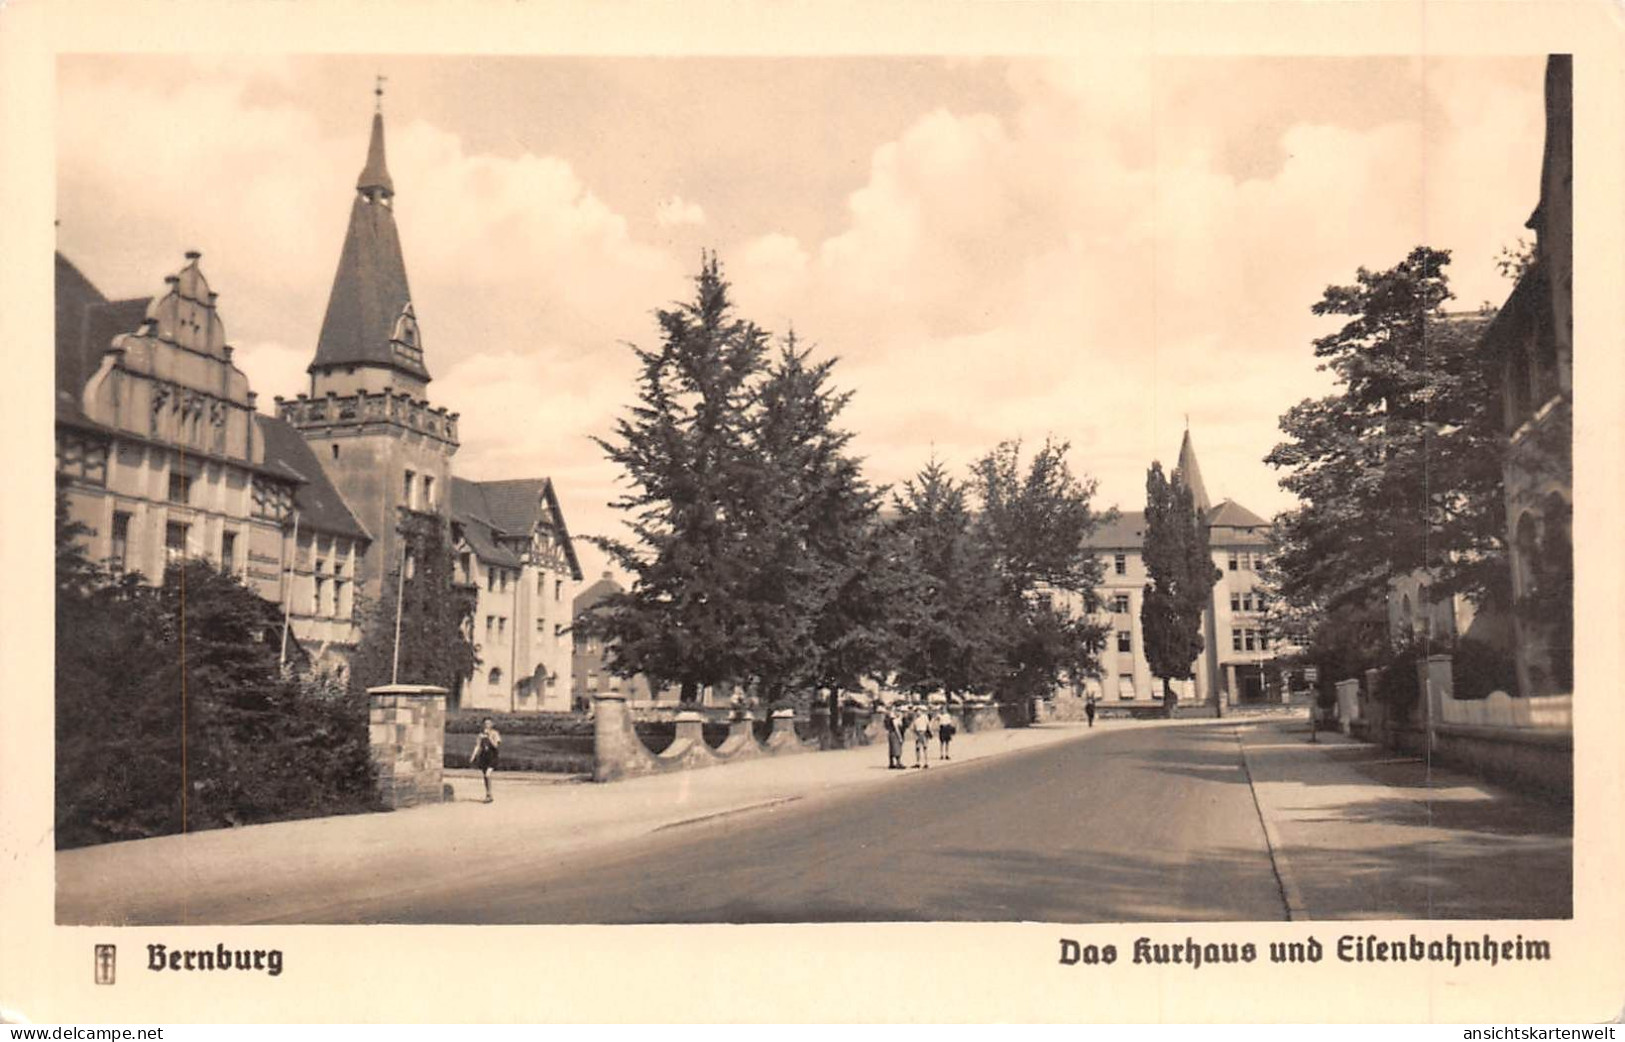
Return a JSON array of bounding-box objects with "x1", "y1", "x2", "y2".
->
[{"x1": 276, "y1": 88, "x2": 458, "y2": 610}]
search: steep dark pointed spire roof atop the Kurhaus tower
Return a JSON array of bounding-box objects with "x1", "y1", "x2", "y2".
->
[{"x1": 309, "y1": 108, "x2": 429, "y2": 380}]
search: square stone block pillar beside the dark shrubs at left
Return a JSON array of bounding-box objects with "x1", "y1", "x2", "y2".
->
[{"x1": 367, "y1": 684, "x2": 445, "y2": 810}]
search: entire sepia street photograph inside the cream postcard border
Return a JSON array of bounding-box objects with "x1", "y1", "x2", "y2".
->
[{"x1": 55, "y1": 55, "x2": 1575, "y2": 923}]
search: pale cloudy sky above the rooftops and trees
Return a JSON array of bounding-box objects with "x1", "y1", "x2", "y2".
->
[{"x1": 57, "y1": 55, "x2": 1544, "y2": 572}]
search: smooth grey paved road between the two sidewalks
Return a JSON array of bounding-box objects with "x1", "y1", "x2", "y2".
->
[{"x1": 373, "y1": 725, "x2": 1285, "y2": 923}]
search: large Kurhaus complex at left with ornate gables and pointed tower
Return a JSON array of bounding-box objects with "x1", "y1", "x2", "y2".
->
[{"x1": 55, "y1": 97, "x2": 580, "y2": 712}]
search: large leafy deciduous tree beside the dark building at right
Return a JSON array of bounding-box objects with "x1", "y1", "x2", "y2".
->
[{"x1": 1266, "y1": 247, "x2": 1506, "y2": 611}]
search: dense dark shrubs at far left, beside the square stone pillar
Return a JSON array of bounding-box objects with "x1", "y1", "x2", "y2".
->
[{"x1": 55, "y1": 553, "x2": 375, "y2": 849}]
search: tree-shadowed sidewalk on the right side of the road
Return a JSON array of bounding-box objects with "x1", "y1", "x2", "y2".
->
[{"x1": 1237, "y1": 720, "x2": 1573, "y2": 918}]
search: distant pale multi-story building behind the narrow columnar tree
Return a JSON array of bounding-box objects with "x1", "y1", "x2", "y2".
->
[{"x1": 1084, "y1": 431, "x2": 1284, "y2": 706}]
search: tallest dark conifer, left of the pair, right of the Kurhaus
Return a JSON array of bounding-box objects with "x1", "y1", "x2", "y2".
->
[{"x1": 588, "y1": 255, "x2": 767, "y2": 702}]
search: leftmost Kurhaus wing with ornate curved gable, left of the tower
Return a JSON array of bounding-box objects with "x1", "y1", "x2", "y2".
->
[{"x1": 57, "y1": 252, "x2": 371, "y2": 676}]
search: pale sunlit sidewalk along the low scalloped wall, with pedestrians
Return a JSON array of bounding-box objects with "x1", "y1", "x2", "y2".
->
[{"x1": 57, "y1": 723, "x2": 1136, "y2": 925}]
